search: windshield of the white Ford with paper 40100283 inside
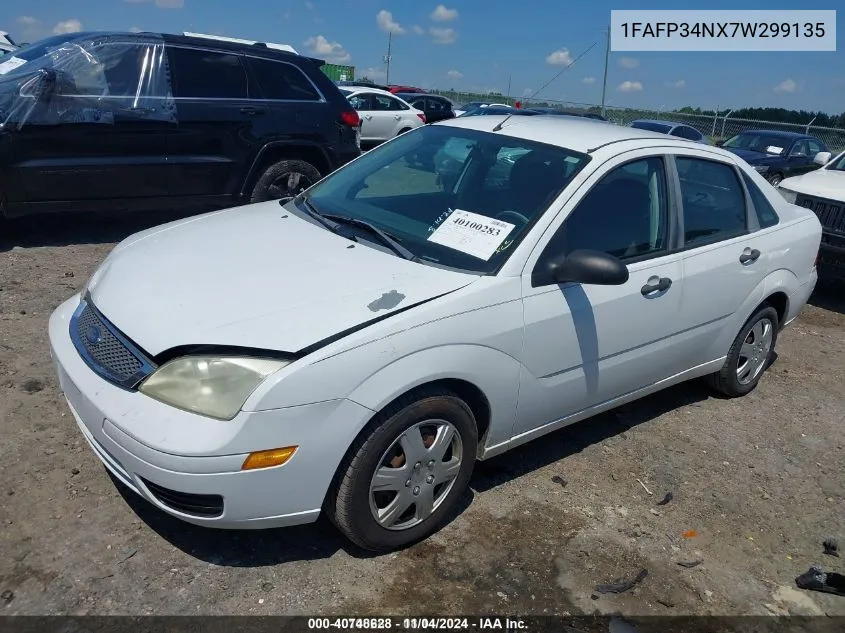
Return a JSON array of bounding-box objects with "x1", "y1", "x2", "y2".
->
[{"x1": 300, "y1": 126, "x2": 589, "y2": 274}]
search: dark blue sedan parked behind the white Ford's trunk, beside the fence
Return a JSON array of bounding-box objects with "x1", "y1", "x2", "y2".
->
[{"x1": 718, "y1": 130, "x2": 830, "y2": 186}]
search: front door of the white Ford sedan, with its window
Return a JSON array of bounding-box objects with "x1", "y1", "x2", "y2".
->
[{"x1": 514, "y1": 156, "x2": 684, "y2": 435}]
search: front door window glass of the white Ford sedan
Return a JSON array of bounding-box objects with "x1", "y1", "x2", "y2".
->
[{"x1": 541, "y1": 157, "x2": 668, "y2": 261}]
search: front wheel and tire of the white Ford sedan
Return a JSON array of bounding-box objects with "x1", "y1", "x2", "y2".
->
[{"x1": 326, "y1": 389, "x2": 478, "y2": 552}]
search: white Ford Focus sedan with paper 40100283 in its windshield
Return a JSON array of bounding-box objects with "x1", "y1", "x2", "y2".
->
[{"x1": 49, "y1": 116, "x2": 821, "y2": 550}]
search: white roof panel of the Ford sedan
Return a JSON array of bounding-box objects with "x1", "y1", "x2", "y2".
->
[{"x1": 437, "y1": 114, "x2": 733, "y2": 157}]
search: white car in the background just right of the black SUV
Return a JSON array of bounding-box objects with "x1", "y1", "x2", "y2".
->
[{"x1": 340, "y1": 87, "x2": 425, "y2": 145}]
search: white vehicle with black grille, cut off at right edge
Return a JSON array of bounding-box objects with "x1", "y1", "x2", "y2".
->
[{"x1": 778, "y1": 152, "x2": 845, "y2": 279}]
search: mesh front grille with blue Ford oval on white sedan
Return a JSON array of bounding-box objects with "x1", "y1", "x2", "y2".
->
[{"x1": 70, "y1": 299, "x2": 154, "y2": 389}]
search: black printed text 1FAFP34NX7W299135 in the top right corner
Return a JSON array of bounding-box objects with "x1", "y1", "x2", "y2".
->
[{"x1": 619, "y1": 22, "x2": 825, "y2": 38}]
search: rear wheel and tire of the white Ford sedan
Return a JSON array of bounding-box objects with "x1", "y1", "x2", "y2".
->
[{"x1": 708, "y1": 304, "x2": 779, "y2": 398}]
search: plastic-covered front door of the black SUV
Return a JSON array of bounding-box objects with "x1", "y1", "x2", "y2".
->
[{"x1": 14, "y1": 42, "x2": 174, "y2": 205}]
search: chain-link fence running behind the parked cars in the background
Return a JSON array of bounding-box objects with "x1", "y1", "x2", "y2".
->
[{"x1": 431, "y1": 90, "x2": 845, "y2": 154}]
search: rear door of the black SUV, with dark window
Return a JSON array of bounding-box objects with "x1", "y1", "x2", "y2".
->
[{"x1": 161, "y1": 45, "x2": 260, "y2": 197}]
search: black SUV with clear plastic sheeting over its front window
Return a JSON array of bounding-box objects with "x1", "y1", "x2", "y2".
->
[{"x1": 0, "y1": 33, "x2": 361, "y2": 217}]
